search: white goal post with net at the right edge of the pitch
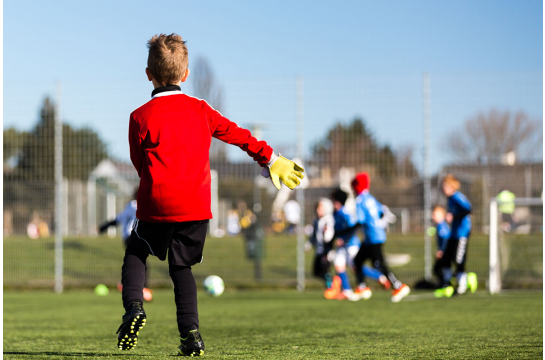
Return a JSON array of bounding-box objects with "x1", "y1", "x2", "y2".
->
[{"x1": 488, "y1": 198, "x2": 543, "y2": 294}]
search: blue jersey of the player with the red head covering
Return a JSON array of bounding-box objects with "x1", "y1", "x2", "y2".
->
[{"x1": 356, "y1": 190, "x2": 386, "y2": 245}]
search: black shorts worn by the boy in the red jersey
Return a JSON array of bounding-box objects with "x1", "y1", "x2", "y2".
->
[{"x1": 127, "y1": 219, "x2": 209, "y2": 266}]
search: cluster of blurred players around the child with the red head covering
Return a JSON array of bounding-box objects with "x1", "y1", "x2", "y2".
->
[{"x1": 310, "y1": 172, "x2": 410, "y2": 302}]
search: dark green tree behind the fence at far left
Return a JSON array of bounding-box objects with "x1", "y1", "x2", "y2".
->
[{"x1": 3, "y1": 98, "x2": 107, "y2": 232}]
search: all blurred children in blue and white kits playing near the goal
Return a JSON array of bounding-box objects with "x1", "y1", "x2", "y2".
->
[{"x1": 310, "y1": 173, "x2": 477, "y2": 302}]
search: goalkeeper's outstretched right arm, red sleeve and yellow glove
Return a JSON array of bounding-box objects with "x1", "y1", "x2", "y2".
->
[{"x1": 204, "y1": 103, "x2": 305, "y2": 190}]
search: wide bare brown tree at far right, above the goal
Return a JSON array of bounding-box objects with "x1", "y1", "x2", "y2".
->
[{"x1": 445, "y1": 109, "x2": 543, "y2": 165}]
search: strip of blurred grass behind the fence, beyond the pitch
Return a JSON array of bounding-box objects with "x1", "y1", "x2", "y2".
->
[{"x1": 7, "y1": 234, "x2": 543, "y2": 289}]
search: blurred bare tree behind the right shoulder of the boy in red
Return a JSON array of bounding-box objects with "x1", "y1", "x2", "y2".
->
[{"x1": 191, "y1": 57, "x2": 227, "y2": 161}]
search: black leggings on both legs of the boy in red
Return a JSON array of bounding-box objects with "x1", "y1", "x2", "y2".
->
[{"x1": 121, "y1": 242, "x2": 199, "y2": 336}]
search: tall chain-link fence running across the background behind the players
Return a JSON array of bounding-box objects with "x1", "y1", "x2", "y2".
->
[{"x1": 3, "y1": 73, "x2": 543, "y2": 287}]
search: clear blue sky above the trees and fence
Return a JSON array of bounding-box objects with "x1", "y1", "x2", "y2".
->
[{"x1": 4, "y1": 0, "x2": 543, "y2": 169}]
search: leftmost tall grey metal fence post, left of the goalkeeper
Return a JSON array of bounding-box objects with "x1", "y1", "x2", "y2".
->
[{"x1": 54, "y1": 82, "x2": 64, "y2": 294}]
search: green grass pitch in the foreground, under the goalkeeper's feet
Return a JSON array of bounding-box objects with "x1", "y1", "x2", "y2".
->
[{"x1": 3, "y1": 289, "x2": 543, "y2": 359}]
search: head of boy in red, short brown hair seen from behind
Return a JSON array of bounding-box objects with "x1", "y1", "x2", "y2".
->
[{"x1": 148, "y1": 34, "x2": 188, "y2": 86}]
